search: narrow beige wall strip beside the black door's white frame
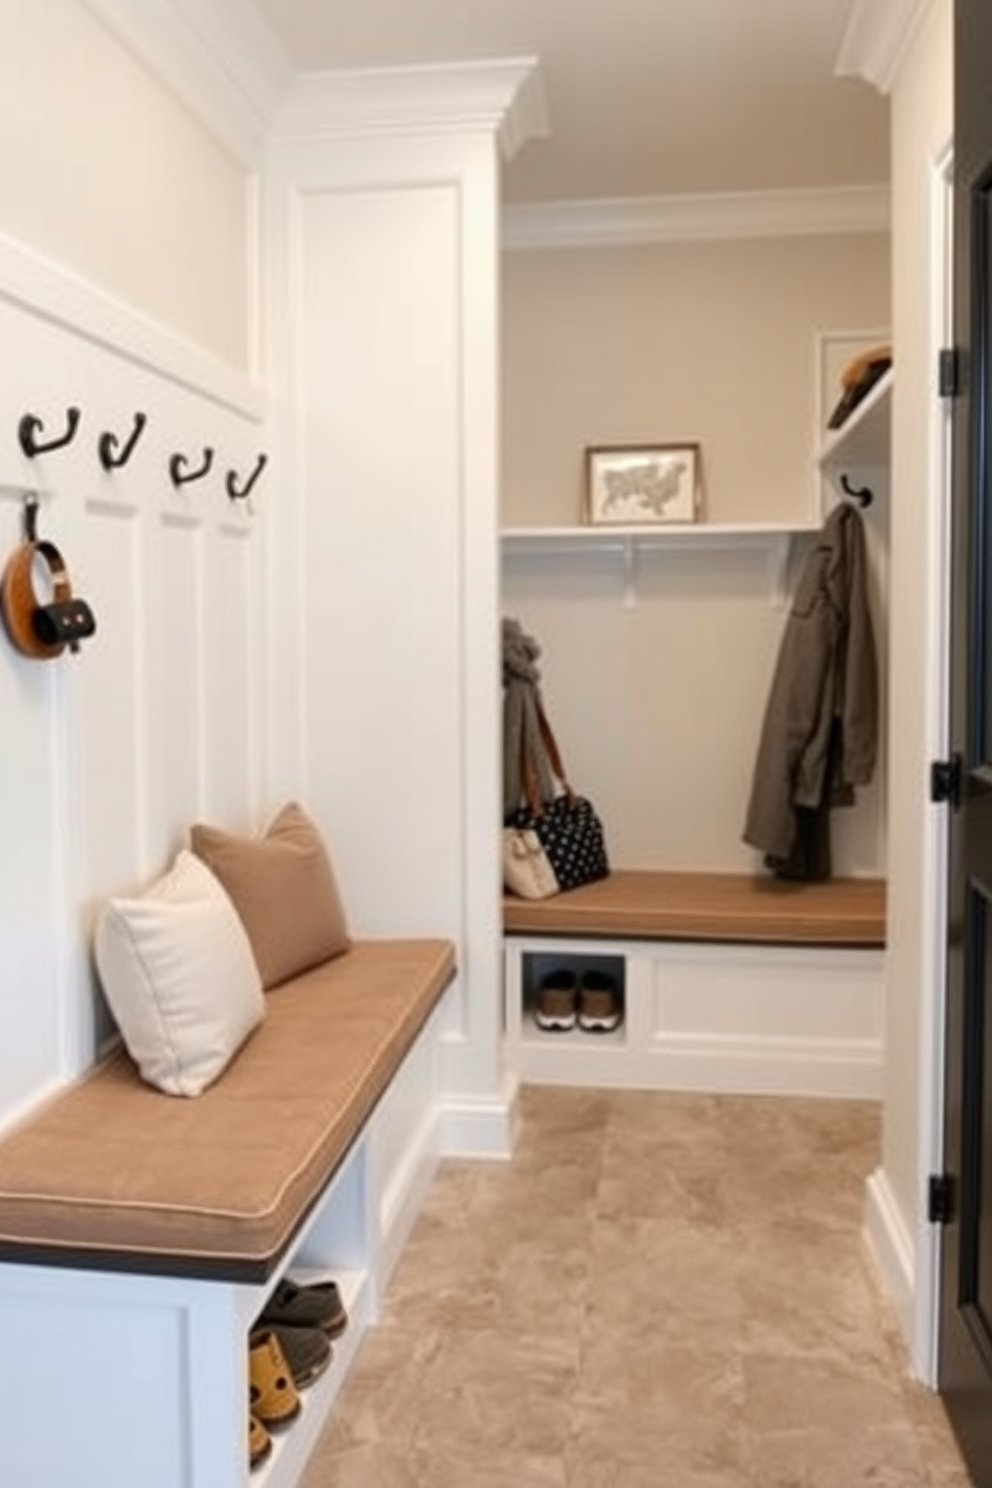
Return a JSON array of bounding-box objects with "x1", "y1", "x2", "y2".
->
[{"x1": 883, "y1": 0, "x2": 953, "y2": 1321}]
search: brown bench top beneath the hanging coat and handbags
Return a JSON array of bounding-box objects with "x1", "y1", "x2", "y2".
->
[{"x1": 503, "y1": 869, "x2": 885, "y2": 946}]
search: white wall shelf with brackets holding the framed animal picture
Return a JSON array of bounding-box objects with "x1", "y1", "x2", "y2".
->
[{"x1": 501, "y1": 521, "x2": 818, "y2": 606}]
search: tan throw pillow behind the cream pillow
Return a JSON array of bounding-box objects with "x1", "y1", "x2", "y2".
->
[{"x1": 190, "y1": 801, "x2": 351, "y2": 991}]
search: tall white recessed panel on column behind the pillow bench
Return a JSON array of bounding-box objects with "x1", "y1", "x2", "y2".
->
[{"x1": 294, "y1": 185, "x2": 464, "y2": 934}]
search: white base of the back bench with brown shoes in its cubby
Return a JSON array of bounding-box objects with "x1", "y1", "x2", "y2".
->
[{"x1": 504, "y1": 936, "x2": 885, "y2": 1100}]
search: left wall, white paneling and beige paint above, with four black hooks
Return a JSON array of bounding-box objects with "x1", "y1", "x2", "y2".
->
[{"x1": 0, "y1": 0, "x2": 268, "y2": 1126}]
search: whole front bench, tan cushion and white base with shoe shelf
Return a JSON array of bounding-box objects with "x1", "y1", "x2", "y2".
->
[{"x1": 0, "y1": 940, "x2": 455, "y2": 1488}]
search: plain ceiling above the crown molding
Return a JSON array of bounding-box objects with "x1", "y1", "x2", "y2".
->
[{"x1": 256, "y1": 0, "x2": 888, "y2": 202}]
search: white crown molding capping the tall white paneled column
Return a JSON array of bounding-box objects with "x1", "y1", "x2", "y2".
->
[{"x1": 274, "y1": 57, "x2": 547, "y2": 159}]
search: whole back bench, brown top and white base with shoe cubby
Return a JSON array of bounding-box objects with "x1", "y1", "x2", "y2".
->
[{"x1": 503, "y1": 870, "x2": 885, "y2": 1097}]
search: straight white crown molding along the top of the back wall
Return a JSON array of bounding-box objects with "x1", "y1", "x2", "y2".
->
[{"x1": 503, "y1": 186, "x2": 891, "y2": 248}]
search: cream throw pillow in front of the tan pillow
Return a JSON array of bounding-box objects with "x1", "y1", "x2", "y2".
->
[{"x1": 94, "y1": 850, "x2": 265, "y2": 1095}]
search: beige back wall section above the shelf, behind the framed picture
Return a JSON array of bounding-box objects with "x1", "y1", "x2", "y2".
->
[{"x1": 503, "y1": 235, "x2": 889, "y2": 525}]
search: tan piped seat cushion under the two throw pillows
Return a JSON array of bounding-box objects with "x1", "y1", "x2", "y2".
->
[{"x1": 0, "y1": 940, "x2": 455, "y2": 1280}]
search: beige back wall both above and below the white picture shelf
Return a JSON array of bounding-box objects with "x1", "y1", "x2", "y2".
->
[{"x1": 503, "y1": 237, "x2": 889, "y2": 873}]
